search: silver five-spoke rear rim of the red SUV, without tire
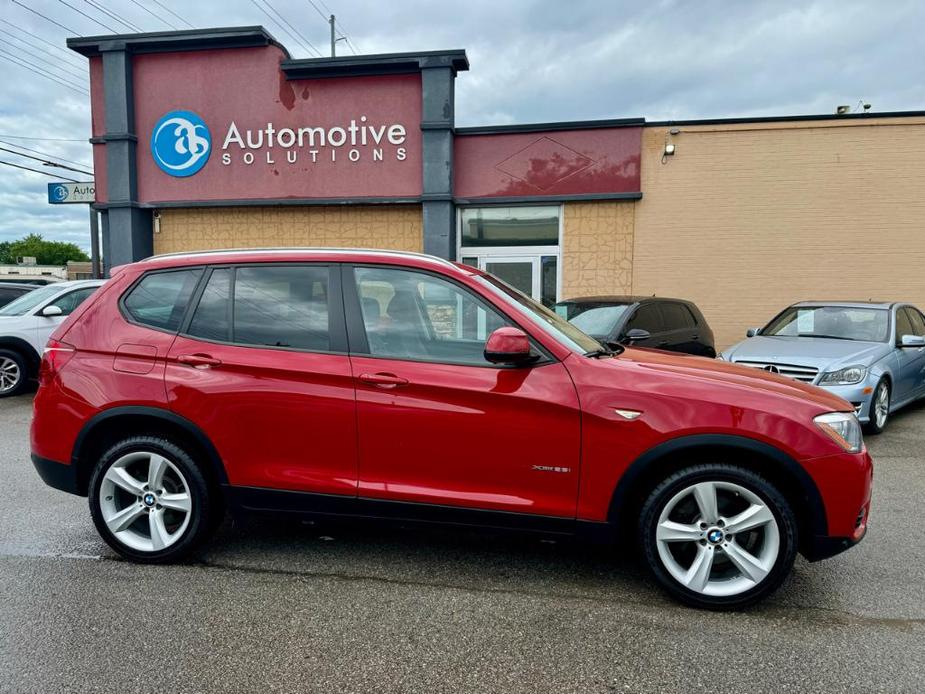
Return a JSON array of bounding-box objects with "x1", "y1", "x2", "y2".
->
[{"x1": 99, "y1": 451, "x2": 192, "y2": 552}]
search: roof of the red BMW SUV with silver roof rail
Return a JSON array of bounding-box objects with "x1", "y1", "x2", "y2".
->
[{"x1": 134, "y1": 248, "x2": 458, "y2": 272}]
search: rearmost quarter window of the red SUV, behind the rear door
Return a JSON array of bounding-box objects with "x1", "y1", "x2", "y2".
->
[{"x1": 122, "y1": 268, "x2": 202, "y2": 331}]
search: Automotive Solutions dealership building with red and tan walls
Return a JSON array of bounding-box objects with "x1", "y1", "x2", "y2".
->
[{"x1": 68, "y1": 27, "x2": 925, "y2": 346}]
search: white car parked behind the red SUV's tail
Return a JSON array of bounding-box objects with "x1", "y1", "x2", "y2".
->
[{"x1": 0, "y1": 280, "x2": 105, "y2": 398}]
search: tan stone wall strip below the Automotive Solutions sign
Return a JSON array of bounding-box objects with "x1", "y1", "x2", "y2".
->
[{"x1": 154, "y1": 205, "x2": 423, "y2": 253}]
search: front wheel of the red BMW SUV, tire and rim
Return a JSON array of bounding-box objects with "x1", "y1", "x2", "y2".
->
[{"x1": 640, "y1": 464, "x2": 797, "y2": 610}]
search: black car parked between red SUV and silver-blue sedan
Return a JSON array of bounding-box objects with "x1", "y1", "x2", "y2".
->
[{"x1": 556, "y1": 296, "x2": 716, "y2": 359}]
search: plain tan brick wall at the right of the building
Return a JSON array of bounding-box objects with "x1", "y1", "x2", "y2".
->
[{"x1": 633, "y1": 118, "x2": 925, "y2": 354}]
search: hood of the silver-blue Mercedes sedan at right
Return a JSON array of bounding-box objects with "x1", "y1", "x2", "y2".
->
[{"x1": 723, "y1": 335, "x2": 890, "y2": 369}]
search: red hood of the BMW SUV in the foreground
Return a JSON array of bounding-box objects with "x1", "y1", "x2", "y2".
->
[{"x1": 601, "y1": 348, "x2": 854, "y2": 412}]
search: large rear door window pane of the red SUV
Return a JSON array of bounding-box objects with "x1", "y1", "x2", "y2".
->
[{"x1": 232, "y1": 266, "x2": 331, "y2": 352}]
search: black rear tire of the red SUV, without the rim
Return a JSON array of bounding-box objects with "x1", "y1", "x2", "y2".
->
[{"x1": 88, "y1": 436, "x2": 222, "y2": 564}]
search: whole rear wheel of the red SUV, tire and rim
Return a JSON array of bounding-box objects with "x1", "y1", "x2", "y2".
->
[{"x1": 89, "y1": 436, "x2": 218, "y2": 563}]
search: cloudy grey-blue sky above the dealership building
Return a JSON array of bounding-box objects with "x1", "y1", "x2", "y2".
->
[{"x1": 0, "y1": 0, "x2": 925, "y2": 247}]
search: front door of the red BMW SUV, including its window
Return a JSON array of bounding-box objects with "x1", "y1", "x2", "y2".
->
[{"x1": 344, "y1": 266, "x2": 580, "y2": 518}]
